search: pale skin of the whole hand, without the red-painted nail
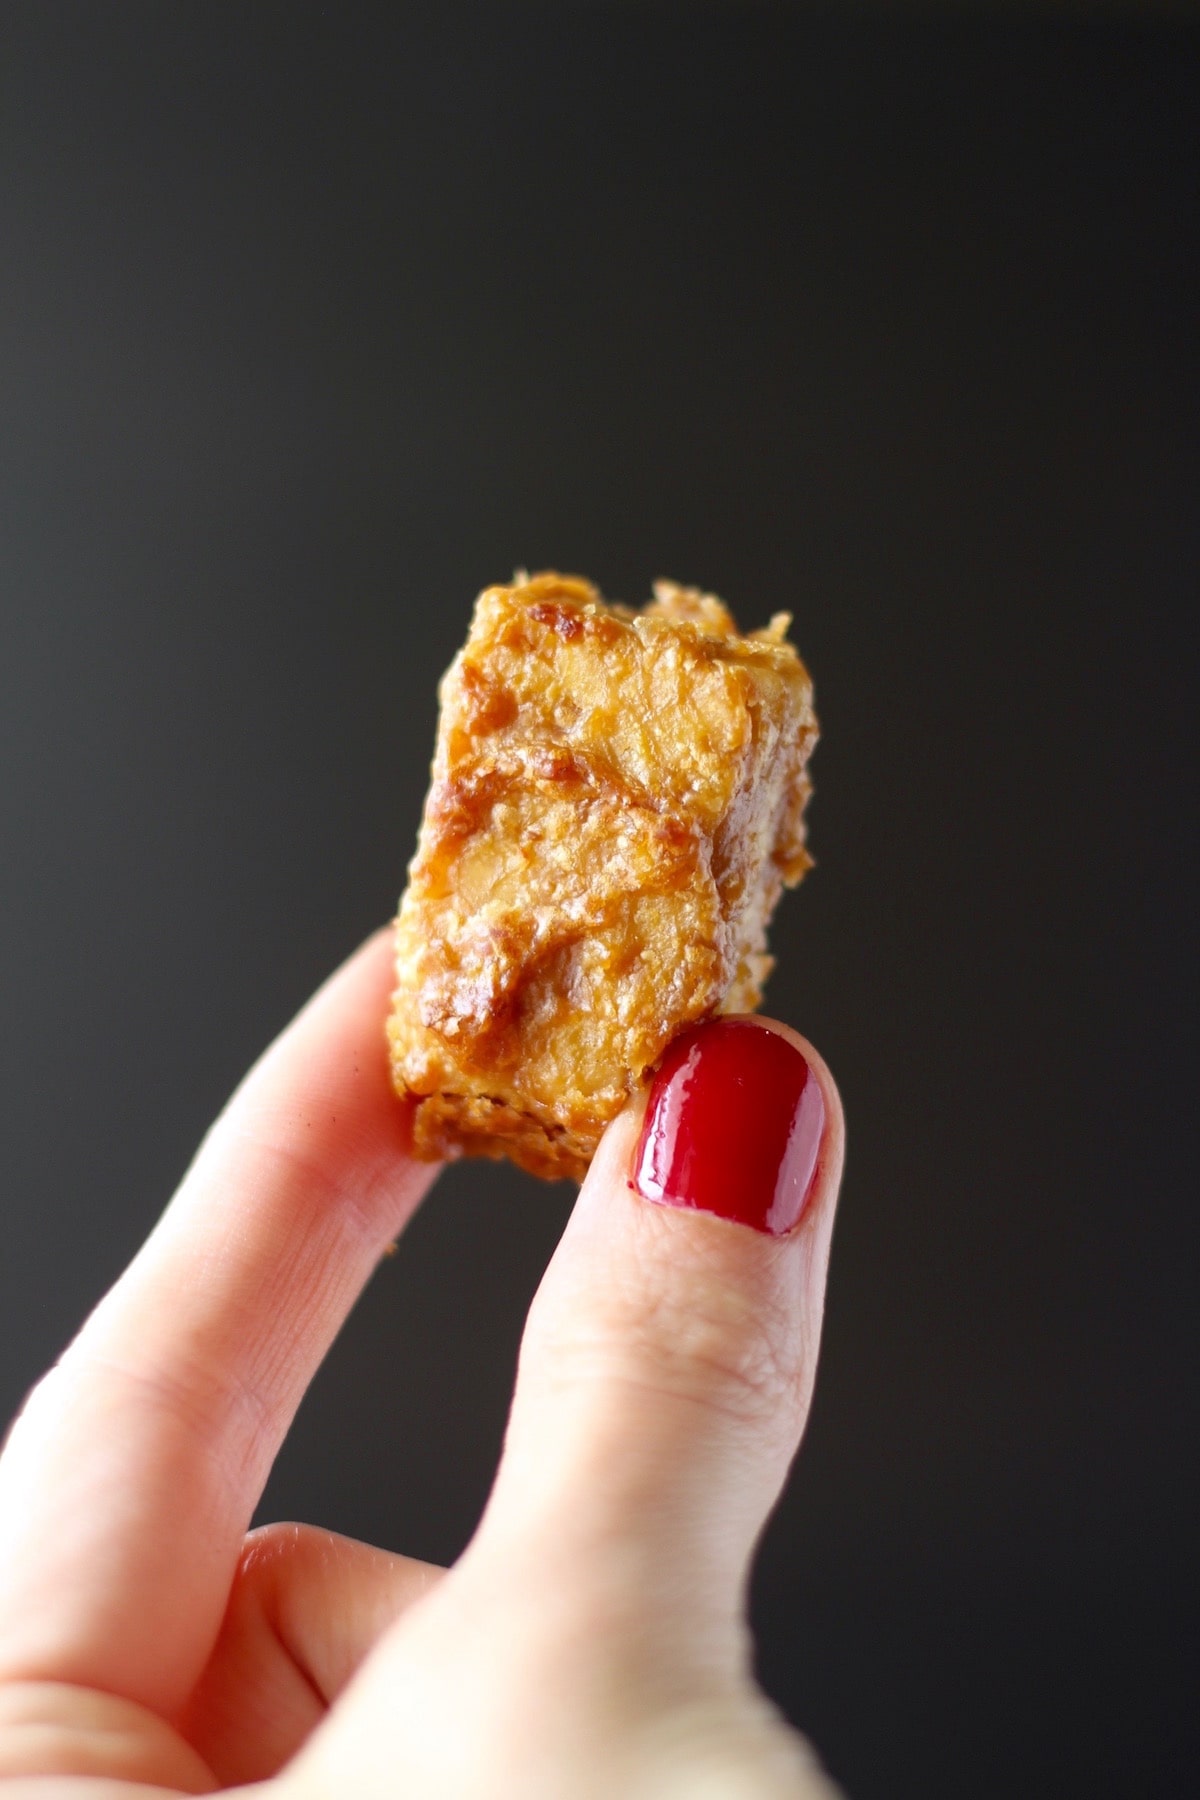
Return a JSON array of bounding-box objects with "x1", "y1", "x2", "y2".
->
[{"x1": 0, "y1": 932, "x2": 844, "y2": 1800}]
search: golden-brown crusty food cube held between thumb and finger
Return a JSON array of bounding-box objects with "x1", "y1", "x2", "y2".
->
[{"x1": 389, "y1": 574, "x2": 817, "y2": 1177}]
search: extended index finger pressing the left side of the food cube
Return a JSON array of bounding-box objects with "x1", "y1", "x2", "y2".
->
[{"x1": 0, "y1": 932, "x2": 432, "y2": 1714}]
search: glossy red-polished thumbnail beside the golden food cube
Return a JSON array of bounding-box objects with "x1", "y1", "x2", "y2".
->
[{"x1": 631, "y1": 1017, "x2": 826, "y2": 1237}]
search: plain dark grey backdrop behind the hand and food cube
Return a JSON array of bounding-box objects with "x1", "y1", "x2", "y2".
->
[{"x1": 0, "y1": 0, "x2": 1200, "y2": 1800}]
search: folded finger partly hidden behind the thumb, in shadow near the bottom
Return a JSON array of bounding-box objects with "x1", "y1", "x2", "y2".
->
[{"x1": 180, "y1": 1525, "x2": 444, "y2": 1787}]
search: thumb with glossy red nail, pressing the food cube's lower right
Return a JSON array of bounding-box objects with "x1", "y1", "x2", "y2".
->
[{"x1": 470, "y1": 1019, "x2": 844, "y2": 1654}]
